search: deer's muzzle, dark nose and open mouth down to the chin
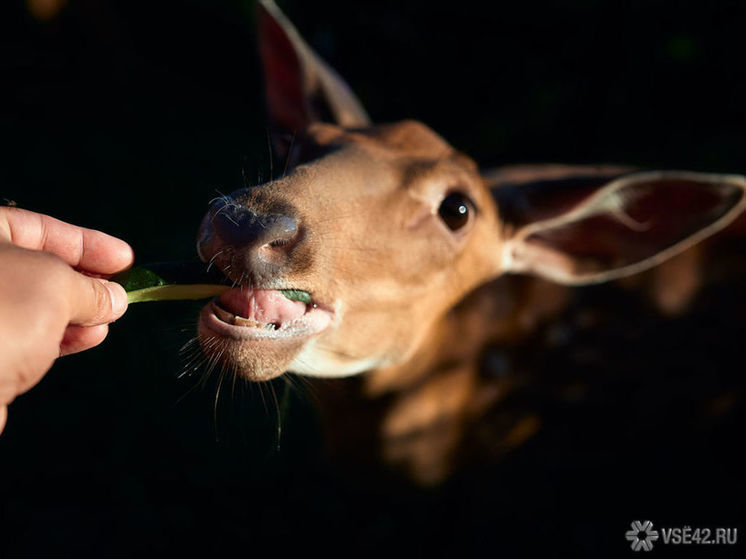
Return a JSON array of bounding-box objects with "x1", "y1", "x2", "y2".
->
[{"x1": 197, "y1": 191, "x2": 334, "y2": 380}]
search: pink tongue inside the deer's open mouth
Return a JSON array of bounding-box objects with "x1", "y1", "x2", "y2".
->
[{"x1": 219, "y1": 288, "x2": 306, "y2": 326}]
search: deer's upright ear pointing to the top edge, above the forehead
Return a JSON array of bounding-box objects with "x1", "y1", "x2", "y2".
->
[{"x1": 257, "y1": 0, "x2": 370, "y2": 144}]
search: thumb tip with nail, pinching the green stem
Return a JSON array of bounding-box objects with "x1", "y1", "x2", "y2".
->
[{"x1": 69, "y1": 272, "x2": 127, "y2": 326}]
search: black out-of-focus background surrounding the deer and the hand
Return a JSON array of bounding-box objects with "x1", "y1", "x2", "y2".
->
[{"x1": 0, "y1": 0, "x2": 746, "y2": 557}]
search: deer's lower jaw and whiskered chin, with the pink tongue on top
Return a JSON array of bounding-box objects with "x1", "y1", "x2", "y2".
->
[{"x1": 197, "y1": 287, "x2": 333, "y2": 381}]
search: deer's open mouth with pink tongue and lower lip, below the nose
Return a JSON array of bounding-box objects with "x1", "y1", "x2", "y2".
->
[{"x1": 200, "y1": 287, "x2": 332, "y2": 341}]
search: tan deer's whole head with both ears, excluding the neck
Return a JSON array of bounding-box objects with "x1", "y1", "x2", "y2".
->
[{"x1": 198, "y1": 0, "x2": 746, "y2": 380}]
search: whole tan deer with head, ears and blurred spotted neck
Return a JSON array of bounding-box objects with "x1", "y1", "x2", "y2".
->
[{"x1": 197, "y1": 0, "x2": 746, "y2": 484}]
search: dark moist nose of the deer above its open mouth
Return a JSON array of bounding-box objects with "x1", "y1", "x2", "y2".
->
[{"x1": 197, "y1": 200, "x2": 300, "y2": 279}]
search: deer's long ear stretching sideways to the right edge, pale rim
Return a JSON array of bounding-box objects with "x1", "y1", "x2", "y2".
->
[{"x1": 493, "y1": 171, "x2": 746, "y2": 284}]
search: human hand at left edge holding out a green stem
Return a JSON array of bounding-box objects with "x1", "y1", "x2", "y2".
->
[{"x1": 0, "y1": 207, "x2": 133, "y2": 432}]
